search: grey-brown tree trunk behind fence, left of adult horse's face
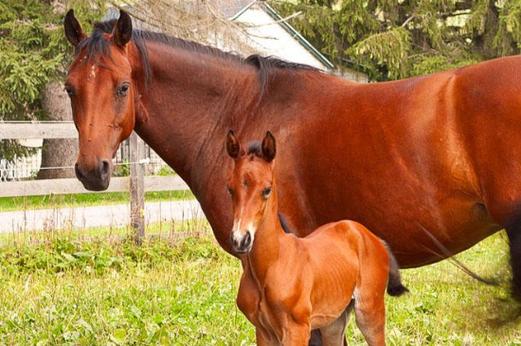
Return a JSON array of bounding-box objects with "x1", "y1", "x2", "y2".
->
[{"x1": 37, "y1": 82, "x2": 78, "y2": 179}]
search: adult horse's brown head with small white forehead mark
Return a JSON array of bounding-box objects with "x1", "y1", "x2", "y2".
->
[{"x1": 64, "y1": 10, "x2": 146, "y2": 191}]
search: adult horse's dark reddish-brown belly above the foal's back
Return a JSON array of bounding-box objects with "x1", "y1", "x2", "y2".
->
[{"x1": 304, "y1": 191, "x2": 501, "y2": 268}]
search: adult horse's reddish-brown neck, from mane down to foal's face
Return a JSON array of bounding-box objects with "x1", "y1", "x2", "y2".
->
[{"x1": 130, "y1": 43, "x2": 258, "y2": 244}]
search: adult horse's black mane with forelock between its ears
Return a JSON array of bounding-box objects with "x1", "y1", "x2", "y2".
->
[{"x1": 77, "y1": 19, "x2": 318, "y2": 92}]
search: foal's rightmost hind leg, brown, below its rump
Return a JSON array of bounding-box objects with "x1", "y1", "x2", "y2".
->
[{"x1": 355, "y1": 287, "x2": 385, "y2": 346}]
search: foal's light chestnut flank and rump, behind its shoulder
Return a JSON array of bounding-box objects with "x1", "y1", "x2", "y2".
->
[{"x1": 298, "y1": 220, "x2": 389, "y2": 328}]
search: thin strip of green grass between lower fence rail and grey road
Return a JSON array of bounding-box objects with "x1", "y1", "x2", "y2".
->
[{"x1": 0, "y1": 191, "x2": 195, "y2": 212}]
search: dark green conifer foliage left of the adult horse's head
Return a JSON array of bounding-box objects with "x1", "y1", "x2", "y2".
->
[{"x1": 0, "y1": 0, "x2": 104, "y2": 160}]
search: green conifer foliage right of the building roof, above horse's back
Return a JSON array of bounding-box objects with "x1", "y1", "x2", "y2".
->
[{"x1": 271, "y1": 0, "x2": 521, "y2": 80}]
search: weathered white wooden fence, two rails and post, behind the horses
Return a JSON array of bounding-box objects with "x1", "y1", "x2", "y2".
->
[{"x1": 0, "y1": 121, "x2": 188, "y2": 242}]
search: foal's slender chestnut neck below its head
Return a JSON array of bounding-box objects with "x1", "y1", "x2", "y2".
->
[{"x1": 248, "y1": 193, "x2": 289, "y2": 287}]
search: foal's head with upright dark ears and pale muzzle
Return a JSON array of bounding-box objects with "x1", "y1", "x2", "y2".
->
[{"x1": 226, "y1": 131, "x2": 276, "y2": 253}]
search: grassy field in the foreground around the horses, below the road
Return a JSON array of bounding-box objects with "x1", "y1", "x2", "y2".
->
[{"x1": 0, "y1": 227, "x2": 521, "y2": 345}]
